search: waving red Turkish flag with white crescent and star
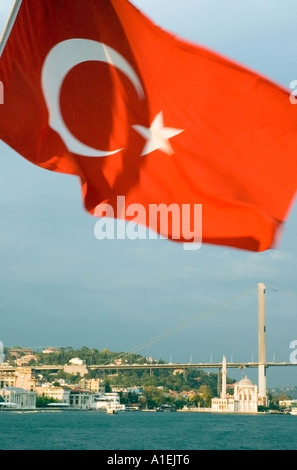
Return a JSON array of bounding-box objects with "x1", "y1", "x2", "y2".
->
[{"x1": 0, "y1": 0, "x2": 297, "y2": 251}]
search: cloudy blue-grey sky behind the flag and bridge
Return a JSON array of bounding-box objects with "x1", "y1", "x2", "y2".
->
[{"x1": 0, "y1": 0, "x2": 297, "y2": 387}]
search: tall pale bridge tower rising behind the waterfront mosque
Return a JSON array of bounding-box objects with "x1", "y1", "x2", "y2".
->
[{"x1": 258, "y1": 283, "x2": 266, "y2": 397}]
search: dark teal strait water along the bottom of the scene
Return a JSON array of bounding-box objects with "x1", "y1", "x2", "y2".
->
[{"x1": 0, "y1": 410, "x2": 297, "y2": 450}]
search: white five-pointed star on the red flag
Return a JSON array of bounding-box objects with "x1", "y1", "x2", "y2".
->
[{"x1": 132, "y1": 111, "x2": 184, "y2": 156}]
